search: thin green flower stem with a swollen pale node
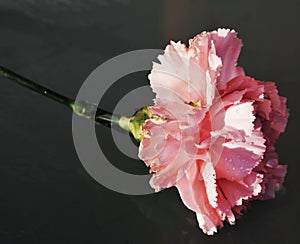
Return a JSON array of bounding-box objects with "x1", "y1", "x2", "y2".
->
[{"x1": 0, "y1": 66, "x2": 130, "y2": 131}]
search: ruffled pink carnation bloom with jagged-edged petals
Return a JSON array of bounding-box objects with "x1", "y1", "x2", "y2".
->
[{"x1": 139, "y1": 29, "x2": 288, "y2": 235}]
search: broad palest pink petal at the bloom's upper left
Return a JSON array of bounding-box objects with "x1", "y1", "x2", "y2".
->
[{"x1": 149, "y1": 42, "x2": 206, "y2": 103}]
